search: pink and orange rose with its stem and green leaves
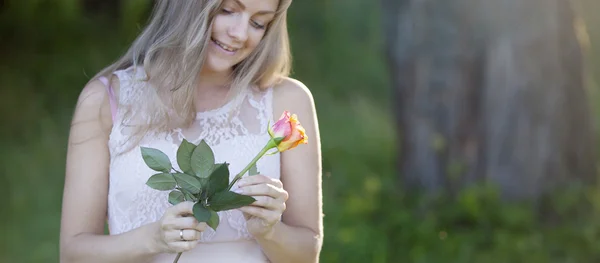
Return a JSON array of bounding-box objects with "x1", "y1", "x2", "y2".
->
[{"x1": 141, "y1": 111, "x2": 308, "y2": 262}]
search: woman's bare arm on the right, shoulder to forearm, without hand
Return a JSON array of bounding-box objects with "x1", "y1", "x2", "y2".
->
[{"x1": 257, "y1": 79, "x2": 323, "y2": 262}]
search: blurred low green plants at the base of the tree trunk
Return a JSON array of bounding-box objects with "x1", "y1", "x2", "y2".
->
[{"x1": 322, "y1": 180, "x2": 600, "y2": 263}]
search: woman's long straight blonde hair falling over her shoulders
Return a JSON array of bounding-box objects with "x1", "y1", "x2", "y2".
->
[{"x1": 92, "y1": 0, "x2": 291, "y2": 146}]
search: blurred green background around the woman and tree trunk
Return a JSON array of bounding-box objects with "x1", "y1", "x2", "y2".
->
[{"x1": 0, "y1": 0, "x2": 600, "y2": 263}]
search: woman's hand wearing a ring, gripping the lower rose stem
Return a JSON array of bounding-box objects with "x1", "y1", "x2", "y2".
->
[{"x1": 153, "y1": 202, "x2": 207, "y2": 253}]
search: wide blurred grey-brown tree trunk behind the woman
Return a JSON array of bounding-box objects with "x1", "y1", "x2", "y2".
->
[{"x1": 384, "y1": 0, "x2": 596, "y2": 199}]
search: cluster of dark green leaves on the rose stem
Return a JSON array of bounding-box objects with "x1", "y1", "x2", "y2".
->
[{"x1": 141, "y1": 139, "x2": 256, "y2": 230}]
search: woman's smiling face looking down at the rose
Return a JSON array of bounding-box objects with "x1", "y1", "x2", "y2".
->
[{"x1": 206, "y1": 0, "x2": 279, "y2": 72}]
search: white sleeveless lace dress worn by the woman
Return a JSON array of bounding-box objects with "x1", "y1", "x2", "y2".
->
[{"x1": 108, "y1": 68, "x2": 280, "y2": 263}]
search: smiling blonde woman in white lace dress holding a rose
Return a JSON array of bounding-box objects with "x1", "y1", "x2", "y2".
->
[{"x1": 60, "y1": 0, "x2": 323, "y2": 263}]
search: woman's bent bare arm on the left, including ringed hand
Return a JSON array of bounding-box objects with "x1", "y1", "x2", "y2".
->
[{"x1": 60, "y1": 80, "x2": 206, "y2": 262}]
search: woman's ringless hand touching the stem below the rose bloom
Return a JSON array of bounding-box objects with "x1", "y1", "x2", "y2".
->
[{"x1": 235, "y1": 174, "x2": 288, "y2": 237}]
